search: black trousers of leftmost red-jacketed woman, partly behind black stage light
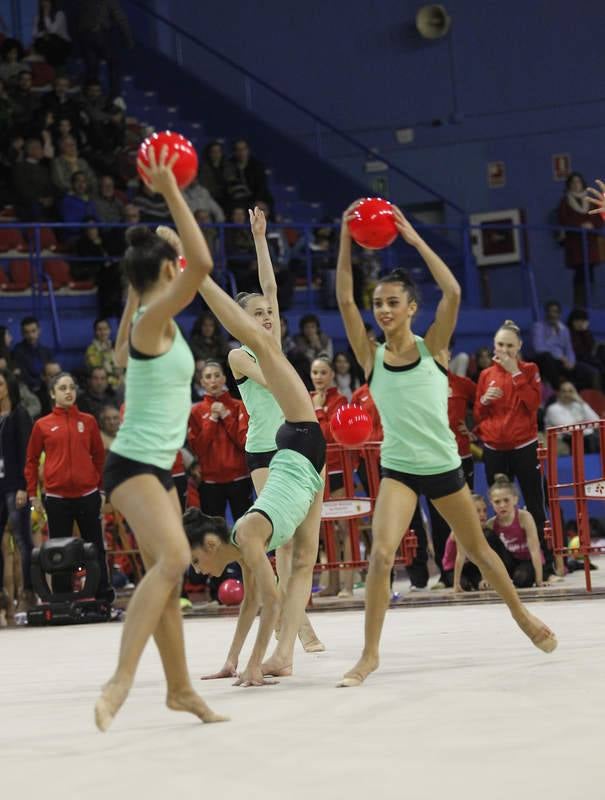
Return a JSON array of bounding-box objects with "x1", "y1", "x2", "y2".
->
[{"x1": 44, "y1": 492, "x2": 110, "y2": 596}]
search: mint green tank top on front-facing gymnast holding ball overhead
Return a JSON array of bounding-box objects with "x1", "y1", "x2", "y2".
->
[{"x1": 370, "y1": 336, "x2": 461, "y2": 475}]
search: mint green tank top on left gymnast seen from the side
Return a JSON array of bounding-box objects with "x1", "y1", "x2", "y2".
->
[{"x1": 110, "y1": 306, "x2": 194, "y2": 470}]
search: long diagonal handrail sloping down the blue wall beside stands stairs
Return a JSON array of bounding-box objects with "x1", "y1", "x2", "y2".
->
[{"x1": 121, "y1": 0, "x2": 466, "y2": 214}]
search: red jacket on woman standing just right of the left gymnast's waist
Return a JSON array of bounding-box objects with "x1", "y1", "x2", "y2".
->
[{"x1": 187, "y1": 392, "x2": 248, "y2": 483}]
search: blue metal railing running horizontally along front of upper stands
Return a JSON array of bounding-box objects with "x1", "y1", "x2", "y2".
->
[{"x1": 0, "y1": 221, "x2": 599, "y2": 347}]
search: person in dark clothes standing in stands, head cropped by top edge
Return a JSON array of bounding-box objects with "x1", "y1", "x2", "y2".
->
[{"x1": 77, "y1": 0, "x2": 134, "y2": 99}]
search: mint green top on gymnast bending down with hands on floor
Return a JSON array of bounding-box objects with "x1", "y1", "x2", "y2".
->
[{"x1": 231, "y1": 449, "x2": 324, "y2": 553}]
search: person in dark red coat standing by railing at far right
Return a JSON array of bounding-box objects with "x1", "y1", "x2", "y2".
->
[{"x1": 559, "y1": 172, "x2": 603, "y2": 306}]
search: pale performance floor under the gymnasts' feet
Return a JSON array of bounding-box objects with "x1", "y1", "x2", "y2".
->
[{"x1": 0, "y1": 600, "x2": 605, "y2": 800}]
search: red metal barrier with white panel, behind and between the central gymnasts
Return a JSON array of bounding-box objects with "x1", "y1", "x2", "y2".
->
[{"x1": 315, "y1": 442, "x2": 418, "y2": 572}]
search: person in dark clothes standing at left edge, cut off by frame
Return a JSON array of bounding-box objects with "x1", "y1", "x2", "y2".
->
[{"x1": 0, "y1": 369, "x2": 34, "y2": 604}]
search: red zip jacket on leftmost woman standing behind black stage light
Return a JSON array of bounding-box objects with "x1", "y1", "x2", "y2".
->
[{"x1": 25, "y1": 405, "x2": 105, "y2": 498}]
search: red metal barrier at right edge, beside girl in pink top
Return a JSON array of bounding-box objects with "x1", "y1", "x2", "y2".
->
[{"x1": 538, "y1": 420, "x2": 605, "y2": 592}]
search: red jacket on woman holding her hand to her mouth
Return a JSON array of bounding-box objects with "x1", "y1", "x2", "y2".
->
[{"x1": 473, "y1": 361, "x2": 542, "y2": 450}]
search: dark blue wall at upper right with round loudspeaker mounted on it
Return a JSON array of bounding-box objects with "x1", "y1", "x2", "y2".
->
[{"x1": 144, "y1": 0, "x2": 605, "y2": 305}]
